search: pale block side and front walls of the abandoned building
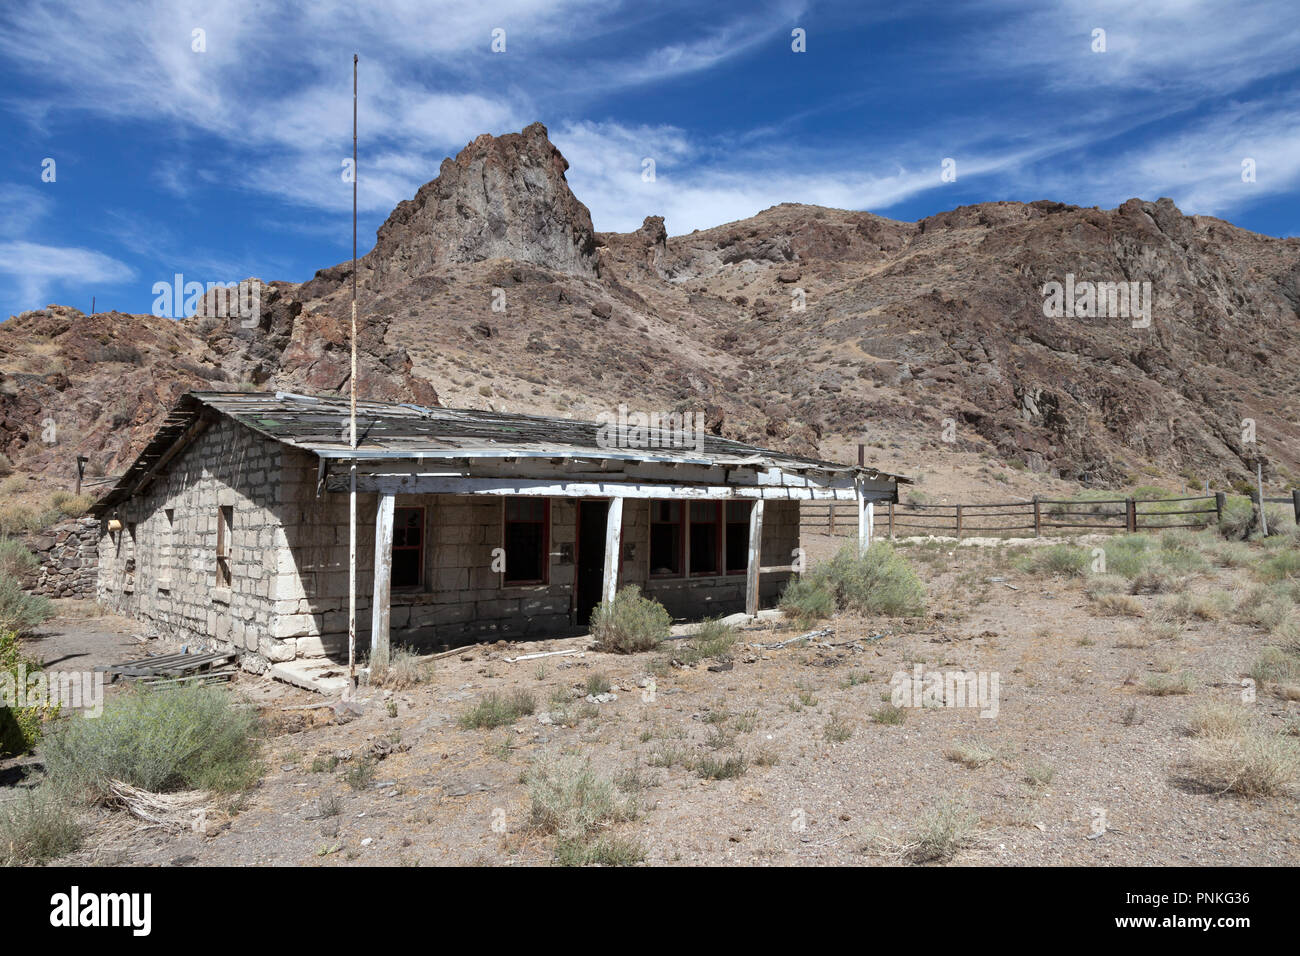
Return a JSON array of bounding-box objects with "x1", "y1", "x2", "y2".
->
[{"x1": 96, "y1": 429, "x2": 798, "y2": 671}]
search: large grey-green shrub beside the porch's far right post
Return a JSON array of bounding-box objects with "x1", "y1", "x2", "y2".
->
[{"x1": 781, "y1": 541, "x2": 926, "y2": 617}]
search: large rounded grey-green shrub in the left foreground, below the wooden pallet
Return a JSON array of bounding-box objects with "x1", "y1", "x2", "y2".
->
[{"x1": 44, "y1": 684, "x2": 261, "y2": 800}]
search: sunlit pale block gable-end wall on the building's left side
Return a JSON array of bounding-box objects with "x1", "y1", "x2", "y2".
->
[{"x1": 96, "y1": 420, "x2": 287, "y2": 672}]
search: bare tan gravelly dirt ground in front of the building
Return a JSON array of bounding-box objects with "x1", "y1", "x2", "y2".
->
[{"x1": 12, "y1": 530, "x2": 1300, "y2": 866}]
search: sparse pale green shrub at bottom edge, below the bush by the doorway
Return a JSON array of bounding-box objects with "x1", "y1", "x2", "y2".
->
[{"x1": 524, "y1": 754, "x2": 645, "y2": 866}]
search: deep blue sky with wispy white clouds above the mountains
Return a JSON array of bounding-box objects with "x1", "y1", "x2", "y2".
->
[{"x1": 0, "y1": 0, "x2": 1300, "y2": 316}]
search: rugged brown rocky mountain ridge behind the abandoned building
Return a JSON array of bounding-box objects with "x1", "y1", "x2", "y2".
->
[{"x1": 0, "y1": 124, "x2": 1300, "y2": 496}]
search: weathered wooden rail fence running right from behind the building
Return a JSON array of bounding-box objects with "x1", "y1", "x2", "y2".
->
[{"x1": 802, "y1": 489, "x2": 1300, "y2": 537}]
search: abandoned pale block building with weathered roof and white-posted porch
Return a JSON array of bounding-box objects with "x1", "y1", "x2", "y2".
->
[{"x1": 92, "y1": 392, "x2": 906, "y2": 671}]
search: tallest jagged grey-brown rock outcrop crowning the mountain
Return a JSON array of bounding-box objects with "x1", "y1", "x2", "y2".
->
[{"x1": 367, "y1": 122, "x2": 595, "y2": 287}]
